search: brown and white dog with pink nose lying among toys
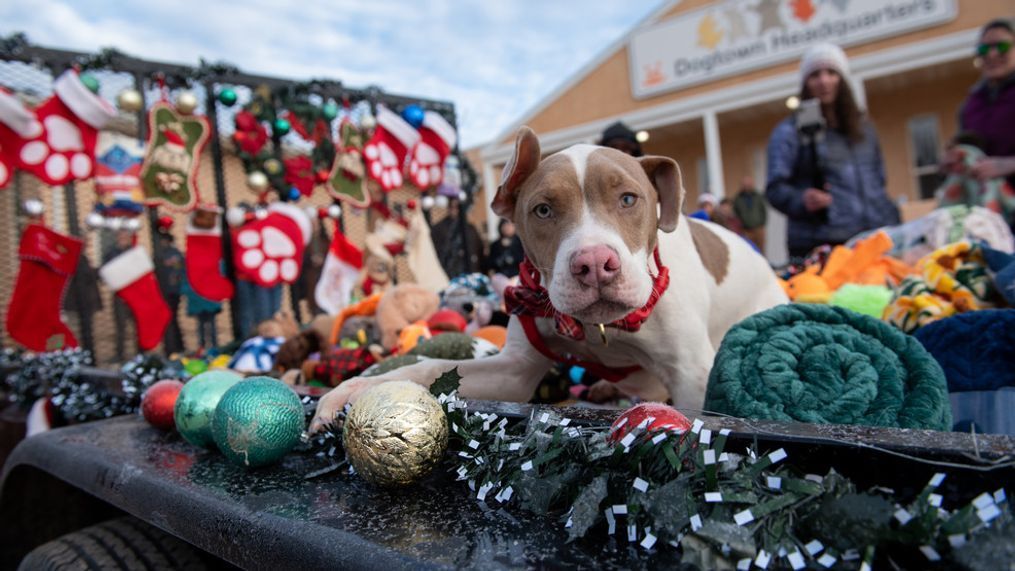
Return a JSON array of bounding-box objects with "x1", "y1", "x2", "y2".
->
[{"x1": 311, "y1": 127, "x2": 787, "y2": 430}]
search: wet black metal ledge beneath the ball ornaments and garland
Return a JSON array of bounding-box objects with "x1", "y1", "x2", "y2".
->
[{"x1": 0, "y1": 403, "x2": 1015, "y2": 571}]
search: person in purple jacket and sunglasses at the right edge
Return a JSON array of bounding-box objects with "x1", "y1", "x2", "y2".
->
[{"x1": 946, "y1": 19, "x2": 1015, "y2": 226}]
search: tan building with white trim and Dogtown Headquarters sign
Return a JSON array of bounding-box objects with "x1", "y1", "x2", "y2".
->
[{"x1": 472, "y1": 0, "x2": 1015, "y2": 264}]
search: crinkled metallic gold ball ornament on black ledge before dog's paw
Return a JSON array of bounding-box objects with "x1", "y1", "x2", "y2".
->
[{"x1": 342, "y1": 380, "x2": 448, "y2": 486}]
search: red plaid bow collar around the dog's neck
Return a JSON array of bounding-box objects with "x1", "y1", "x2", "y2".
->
[{"x1": 504, "y1": 245, "x2": 670, "y2": 341}]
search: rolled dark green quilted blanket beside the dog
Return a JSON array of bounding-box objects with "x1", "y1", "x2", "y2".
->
[{"x1": 704, "y1": 304, "x2": 952, "y2": 430}]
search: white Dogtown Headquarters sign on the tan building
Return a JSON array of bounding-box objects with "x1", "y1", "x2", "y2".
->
[{"x1": 628, "y1": 0, "x2": 956, "y2": 97}]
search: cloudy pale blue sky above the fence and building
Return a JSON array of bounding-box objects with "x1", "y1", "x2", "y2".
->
[{"x1": 0, "y1": 0, "x2": 664, "y2": 149}]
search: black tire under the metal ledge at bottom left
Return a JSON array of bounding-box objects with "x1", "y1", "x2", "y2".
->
[{"x1": 18, "y1": 517, "x2": 206, "y2": 571}]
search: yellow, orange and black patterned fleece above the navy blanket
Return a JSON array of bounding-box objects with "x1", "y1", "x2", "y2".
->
[{"x1": 882, "y1": 241, "x2": 998, "y2": 333}]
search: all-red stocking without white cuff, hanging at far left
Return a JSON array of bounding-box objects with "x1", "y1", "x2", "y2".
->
[{"x1": 7, "y1": 224, "x2": 82, "y2": 351}]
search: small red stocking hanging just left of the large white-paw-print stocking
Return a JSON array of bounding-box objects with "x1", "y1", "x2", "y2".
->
[{"x1": 187, "y1": 206, "x2": 234, "y2": 301}]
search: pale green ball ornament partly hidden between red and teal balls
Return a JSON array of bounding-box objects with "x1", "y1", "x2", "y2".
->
[{"x1": 173, "y1": 370, "x2": 244, "y2": 447}]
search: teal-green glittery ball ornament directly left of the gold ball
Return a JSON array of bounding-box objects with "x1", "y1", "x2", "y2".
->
[{"x1": 211, "y1": 376, "x2": 303, "y2": 468}]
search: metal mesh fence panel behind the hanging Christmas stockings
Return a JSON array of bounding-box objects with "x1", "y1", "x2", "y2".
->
[{"x1": 0, "y1": 35, "x2": 476, "y2": 365}]
